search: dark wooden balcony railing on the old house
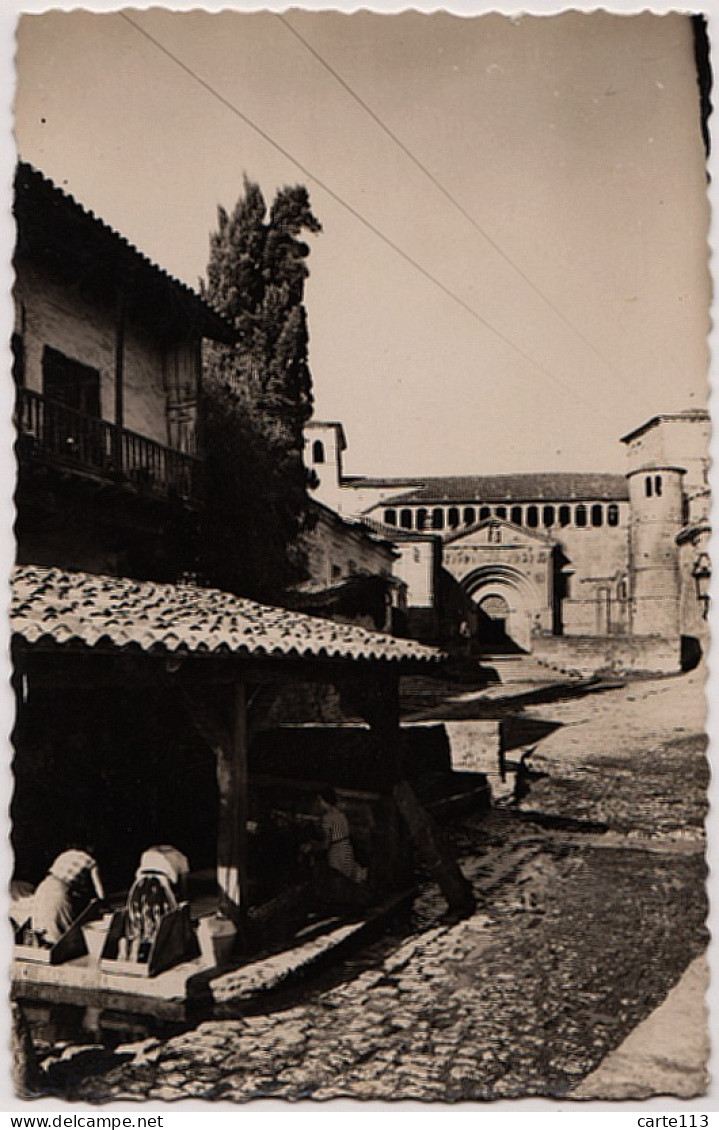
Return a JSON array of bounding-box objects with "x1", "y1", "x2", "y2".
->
[{"x1": 16, "y1": 389, "x2": 201, "y2": 502}]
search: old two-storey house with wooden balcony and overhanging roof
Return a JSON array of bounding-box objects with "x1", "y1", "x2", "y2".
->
[{"x1": 12, "y1": 164, "x2": 238, "y2": 580}]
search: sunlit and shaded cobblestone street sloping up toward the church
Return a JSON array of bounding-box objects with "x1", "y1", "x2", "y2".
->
[{"x1": 29, "y1": 672, "x2": 708, "y2": 1102}]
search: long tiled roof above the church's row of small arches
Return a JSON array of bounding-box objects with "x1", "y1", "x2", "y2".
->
[{"x1": 368, "y1": 471, "x2": 629, "y2": 509}]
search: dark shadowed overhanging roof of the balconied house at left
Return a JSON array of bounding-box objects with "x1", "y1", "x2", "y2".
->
[{"x1": 14, "y1": 162, "x2": 236, "y2": 341}]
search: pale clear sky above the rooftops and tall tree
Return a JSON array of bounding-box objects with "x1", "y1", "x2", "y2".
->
[{"x1": 15, "y1": 8, "x2": 710, "y2": 476}]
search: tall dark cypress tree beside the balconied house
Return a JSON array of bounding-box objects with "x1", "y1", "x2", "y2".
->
[{"x1": 199, "y1": 177, "x2": 321, "y2": 600}]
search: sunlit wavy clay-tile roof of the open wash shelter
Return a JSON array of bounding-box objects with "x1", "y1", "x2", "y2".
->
[{"x1": 10, "y1": 565, "x2": 442, "y2": 662}]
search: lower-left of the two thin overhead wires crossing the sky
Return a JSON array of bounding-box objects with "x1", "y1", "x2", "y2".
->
[{"x1": 116, "y1": 11, "x2": 610, "y2": 403}]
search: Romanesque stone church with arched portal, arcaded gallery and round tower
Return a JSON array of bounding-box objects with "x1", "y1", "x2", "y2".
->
[{"x1": 306, "y1": 409, "x2": 710, "y2": 670}]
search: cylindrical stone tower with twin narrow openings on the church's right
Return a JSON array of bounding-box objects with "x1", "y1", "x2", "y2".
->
[{"x1": 627, "y1": 463, "x2": 684, "y2": 637}]
